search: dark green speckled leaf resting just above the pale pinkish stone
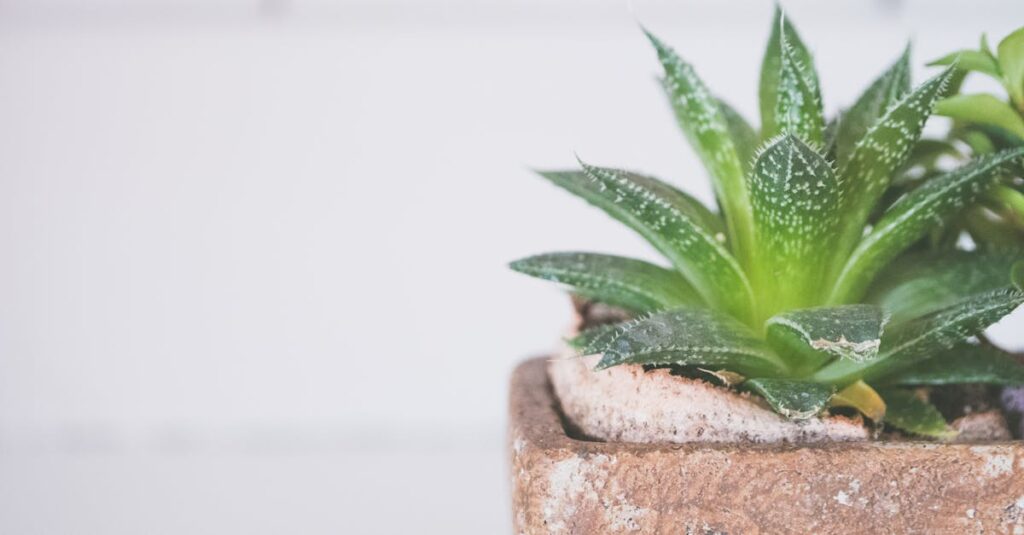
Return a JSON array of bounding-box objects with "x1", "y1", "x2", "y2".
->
[{"x1": 589, "y1": 307, "x2": 784, "y2": 377}]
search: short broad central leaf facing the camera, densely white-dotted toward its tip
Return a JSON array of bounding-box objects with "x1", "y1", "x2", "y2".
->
[{"x1": 750, "y1": 134, "x2": 840, "y2": 309}]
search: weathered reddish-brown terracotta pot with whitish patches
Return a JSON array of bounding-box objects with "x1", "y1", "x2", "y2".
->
[{"x1": 509, "y1": 359, "x2": 1024, "y2": 534}]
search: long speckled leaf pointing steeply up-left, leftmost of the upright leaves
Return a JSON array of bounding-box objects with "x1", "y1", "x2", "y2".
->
[{"x1": 645, "y1": 32, "x2": 753, "y2": 262}]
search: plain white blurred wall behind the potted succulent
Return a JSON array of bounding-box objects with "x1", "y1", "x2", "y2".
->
[{"x1": 0, "y1": 0, "x2": 1024, "y2": 534}]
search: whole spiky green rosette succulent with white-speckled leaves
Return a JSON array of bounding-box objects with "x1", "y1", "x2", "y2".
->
[{"x1": 511, "y1": 11, "x2": 1024, "y2": 437}]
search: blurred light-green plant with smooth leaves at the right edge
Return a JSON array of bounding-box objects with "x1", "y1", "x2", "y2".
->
[{"x1": 909, "y1": 28, "x2": 1024, "y2": 246}]
